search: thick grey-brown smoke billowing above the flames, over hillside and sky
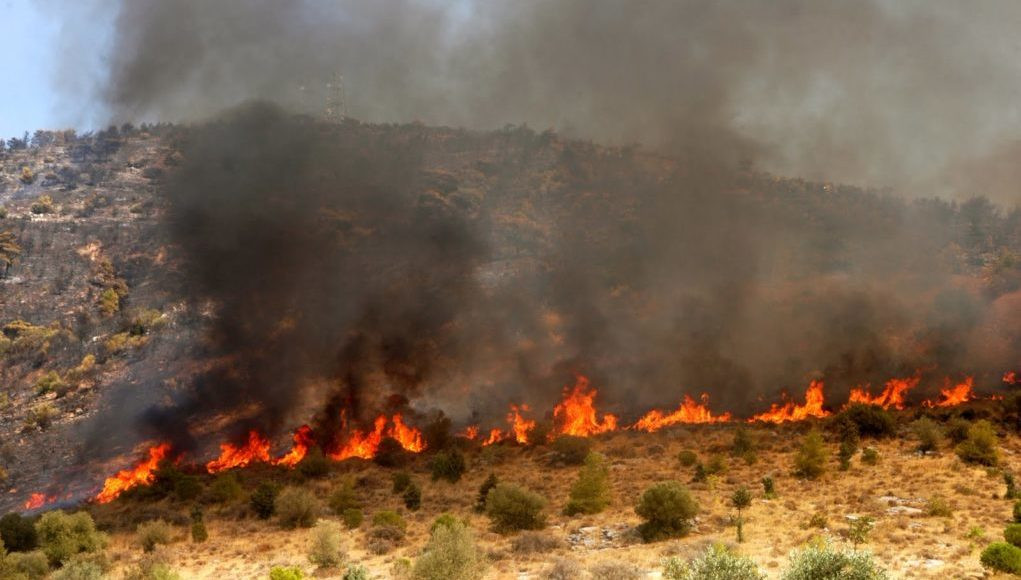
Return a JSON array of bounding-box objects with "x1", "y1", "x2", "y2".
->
[{"x1": 61, "y1": 0, "x2": 1021, "y2": 448}]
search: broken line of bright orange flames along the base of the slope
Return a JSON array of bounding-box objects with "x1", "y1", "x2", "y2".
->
[{"x1": 25, "y1": 372, "x2": 1021, "y2": 510}]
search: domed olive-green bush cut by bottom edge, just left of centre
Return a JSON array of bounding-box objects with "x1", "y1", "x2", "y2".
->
[{"x1": 412, "y1": 522, "x2": 486, "y2": 580}]
